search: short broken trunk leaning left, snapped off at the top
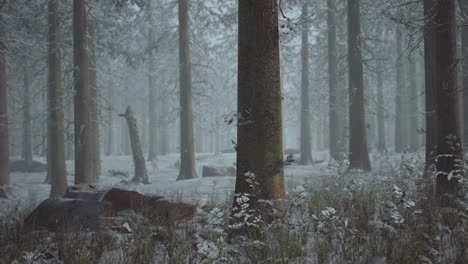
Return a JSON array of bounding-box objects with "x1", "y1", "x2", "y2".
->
[{"x1": 119, "y1": 106, "x2": 149, "y2": 184}]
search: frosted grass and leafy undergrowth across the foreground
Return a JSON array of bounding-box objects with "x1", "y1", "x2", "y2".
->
[{"x1": 0, "y1": 155, "x2": 468, "y2": 264}]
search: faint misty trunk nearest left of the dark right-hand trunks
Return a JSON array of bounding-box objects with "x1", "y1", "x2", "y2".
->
[{"x1": 407, "y1": 56, "x2": 419, "y2": 152}]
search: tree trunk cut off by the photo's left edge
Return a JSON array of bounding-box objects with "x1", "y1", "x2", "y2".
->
[{"x1": 0, "y1": 11, "x2": 10, "y2": 186}]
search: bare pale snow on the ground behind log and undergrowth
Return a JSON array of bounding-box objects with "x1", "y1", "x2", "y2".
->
[{"x1": 3, "y1": 153, "x2": 336, "y2": 211}]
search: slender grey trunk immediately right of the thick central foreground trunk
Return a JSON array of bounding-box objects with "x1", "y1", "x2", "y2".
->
[{"x1": 300, "y1": 2, "x2": 312, "y2": 165}]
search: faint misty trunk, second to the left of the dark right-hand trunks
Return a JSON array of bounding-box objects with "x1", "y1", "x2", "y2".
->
[{"x1": 395, "y1": 26, "x2": 408, "y2": 153}]
